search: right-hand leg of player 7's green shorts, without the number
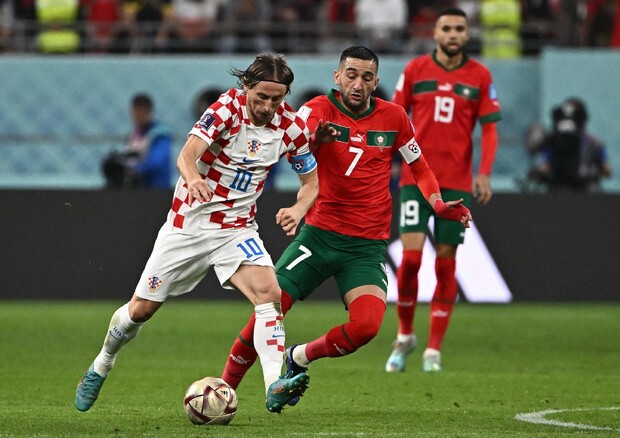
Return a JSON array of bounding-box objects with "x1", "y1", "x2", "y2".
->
[{"x1": 335, "y1": 239, "x2": 388, "y2": 297}]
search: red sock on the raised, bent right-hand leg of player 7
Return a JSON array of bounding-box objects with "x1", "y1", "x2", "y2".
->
[{"x1": 306, "y1": 295, "x2": 385, "y2": 362}]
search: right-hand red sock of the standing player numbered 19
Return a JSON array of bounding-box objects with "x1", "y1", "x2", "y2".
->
[{"x1": 428, "y1": 258, "x2": 457, "y2": 350}]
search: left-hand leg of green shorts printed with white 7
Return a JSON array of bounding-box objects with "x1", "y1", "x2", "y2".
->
[{"x1": 276, "y1": 225, "x2": 338, "y2": 301}]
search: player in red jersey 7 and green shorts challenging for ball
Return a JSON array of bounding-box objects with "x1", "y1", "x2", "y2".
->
[{"x1": 222, "y1": 47, "x2": 471, "y2": 404}]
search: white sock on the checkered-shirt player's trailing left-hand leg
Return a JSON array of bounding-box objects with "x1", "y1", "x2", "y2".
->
[{"x1": 93, "y1": 303, "x2": 144, "y2": 377}]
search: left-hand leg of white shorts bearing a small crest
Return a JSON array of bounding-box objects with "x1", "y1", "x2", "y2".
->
[{"x1": 135, "y1": 224, "x2": 209, "y2": 302}]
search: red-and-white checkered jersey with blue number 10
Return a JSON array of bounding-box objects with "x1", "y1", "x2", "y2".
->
[{"x1": 168, "y1": 88, "x2": 316, "y2": 234}]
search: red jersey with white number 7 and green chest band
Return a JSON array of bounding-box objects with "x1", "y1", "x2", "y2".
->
[{"x1": 298, "y1": 90, "x2": 421, "y2": 239}]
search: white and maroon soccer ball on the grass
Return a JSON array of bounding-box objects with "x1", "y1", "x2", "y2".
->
[{"x1": 183, "y1": 377, "x2": 237, "y2": 424}]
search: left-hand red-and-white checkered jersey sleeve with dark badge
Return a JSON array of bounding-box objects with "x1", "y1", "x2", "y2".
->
[{"x1": 188, "y1": 89, "x2": 240, "y2": 145}]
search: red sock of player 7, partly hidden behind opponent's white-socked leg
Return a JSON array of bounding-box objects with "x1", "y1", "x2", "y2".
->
[{"x1": 222, "y1": 291, "x2": 293, "y2": 389}]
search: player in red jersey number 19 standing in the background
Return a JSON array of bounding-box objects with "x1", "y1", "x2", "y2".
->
[{"x1": 385, "y1": 8, "x2": 501, "y2": 372}]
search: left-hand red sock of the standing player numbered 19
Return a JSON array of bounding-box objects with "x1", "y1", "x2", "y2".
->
[{"x1": 396, "y1": 250, "x2": 422, "y2": 335}]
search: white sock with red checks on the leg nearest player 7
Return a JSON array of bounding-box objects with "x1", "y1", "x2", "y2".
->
[{"x1": 254, "y1": 303, "x2": 285, "y2": 392}]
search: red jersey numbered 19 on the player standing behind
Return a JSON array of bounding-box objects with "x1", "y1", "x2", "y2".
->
[{"x1": 392, "y1": 52, "x2": 501, "y2": 192}]
